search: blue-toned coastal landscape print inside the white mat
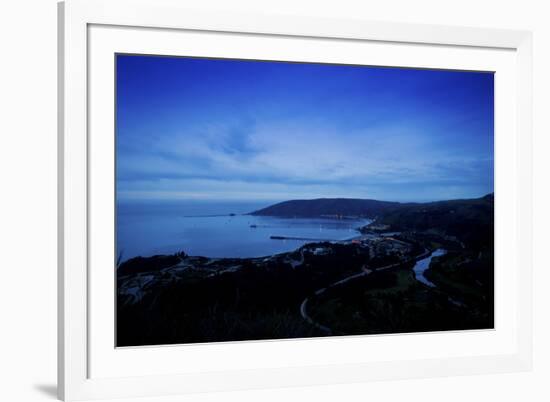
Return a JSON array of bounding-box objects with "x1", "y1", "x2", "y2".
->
[{"x1": 113, "y1": 54, "x2": 494, "y2": 347}]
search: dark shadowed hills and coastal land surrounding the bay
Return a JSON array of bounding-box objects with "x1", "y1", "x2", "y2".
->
[{"x1": 117, "y1": 195, "x2": 494, "y2": 346}]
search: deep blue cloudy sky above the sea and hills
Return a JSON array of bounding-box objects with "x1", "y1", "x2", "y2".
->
[{"x1": 116, "y1": 55, "x2": 494, "y2": 201}]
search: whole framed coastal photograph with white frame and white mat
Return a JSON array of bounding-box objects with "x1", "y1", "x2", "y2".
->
[{"x1": 58, "y1": 0, "x2": 532, "y2": 400}]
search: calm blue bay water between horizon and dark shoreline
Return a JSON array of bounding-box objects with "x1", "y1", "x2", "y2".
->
[{"x1": 117, "y1": 201, "x2": 369, "y2": 260}]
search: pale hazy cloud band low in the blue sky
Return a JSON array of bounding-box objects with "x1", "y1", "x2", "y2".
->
[{"x1": 118, "y1": 114, "x2": 492, "y2": 199}]
